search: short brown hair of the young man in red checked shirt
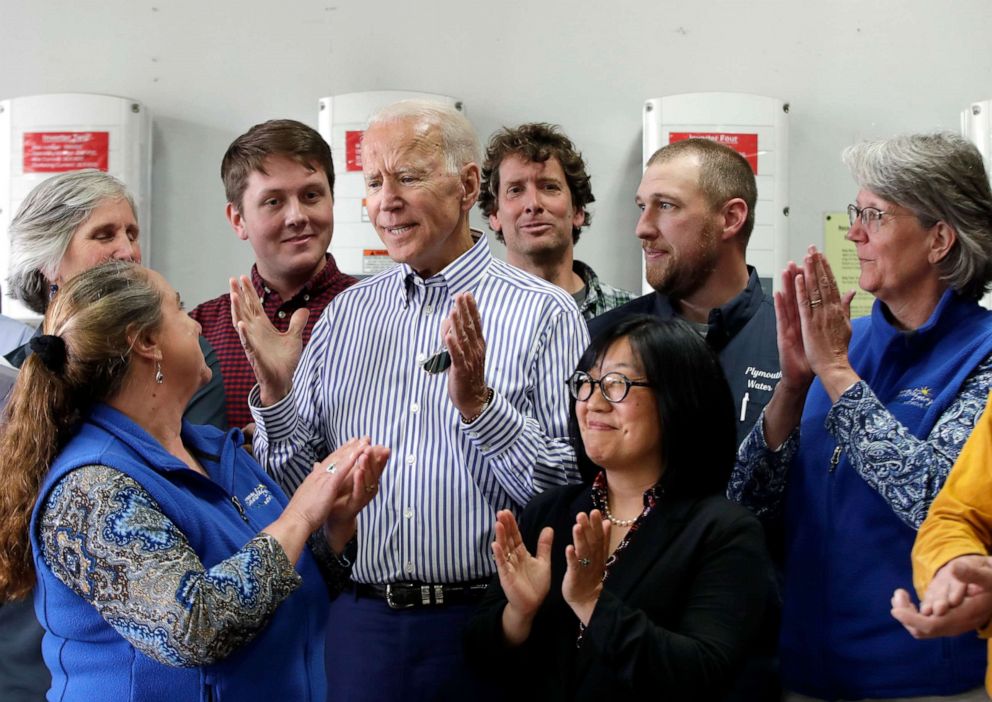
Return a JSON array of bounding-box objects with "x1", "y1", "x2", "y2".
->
[{"x1": 220, "y1": 119, "x2": 334, "y2": 210}]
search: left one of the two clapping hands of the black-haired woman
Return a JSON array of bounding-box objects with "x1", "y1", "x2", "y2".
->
[{"x1": 492, "y1": 509, "x2": 554, "y2": 646}]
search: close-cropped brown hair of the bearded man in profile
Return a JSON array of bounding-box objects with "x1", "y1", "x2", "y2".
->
[{"x1": 646, "y1": 137, "x2": 758, "y2": 246}]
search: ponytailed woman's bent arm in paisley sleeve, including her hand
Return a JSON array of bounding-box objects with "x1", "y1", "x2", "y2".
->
[{"x1": 40, "y1": 442, "x2": 385, "y2": 667}]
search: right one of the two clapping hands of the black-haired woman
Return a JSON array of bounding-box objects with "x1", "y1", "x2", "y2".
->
[{"x1": 561, "y1": 509, "x2": 610, "y2": 624}]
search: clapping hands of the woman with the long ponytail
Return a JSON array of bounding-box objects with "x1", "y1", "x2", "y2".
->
[{"x1": 320, "y1": 436, "x2": 389, "y2": 553}]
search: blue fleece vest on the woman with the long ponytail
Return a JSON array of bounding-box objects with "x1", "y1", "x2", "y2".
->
[{"x1": 31, "y1": 405, "x2": 328, "y2": 702}]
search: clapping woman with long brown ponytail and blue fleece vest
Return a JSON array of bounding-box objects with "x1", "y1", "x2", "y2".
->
[{"x1": 0, "y1": 262, "x2": 388, "y2": 702}]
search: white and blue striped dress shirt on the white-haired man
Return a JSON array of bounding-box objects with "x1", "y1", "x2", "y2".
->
[{"x1": 250, "y1": 237, "x2": 589, "y2": 583}]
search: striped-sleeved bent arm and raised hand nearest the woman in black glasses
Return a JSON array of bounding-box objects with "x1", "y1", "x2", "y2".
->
[{"x1": 441, "y1": 293, "x2": 589, "y2": 507}]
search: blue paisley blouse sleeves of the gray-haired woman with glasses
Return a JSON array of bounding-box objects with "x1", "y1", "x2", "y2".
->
[{"x1": 727, "y1": 357, "x2": 992, "y2": 529}]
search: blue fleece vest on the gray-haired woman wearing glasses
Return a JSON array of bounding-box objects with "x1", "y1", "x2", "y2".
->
[{"x1": 781, "y1": 291, "x2": 992, "y2": 699}]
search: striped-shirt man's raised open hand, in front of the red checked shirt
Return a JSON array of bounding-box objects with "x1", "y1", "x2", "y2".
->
[{"x1": 231, "y1": 276, "x2": 310, "y2": 406}]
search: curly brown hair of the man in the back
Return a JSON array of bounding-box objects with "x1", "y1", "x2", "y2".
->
[{"x1": 479, "y1": 122, "x2": 596, "y2": 243}]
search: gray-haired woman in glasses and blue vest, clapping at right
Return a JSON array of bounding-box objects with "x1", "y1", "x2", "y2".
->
[{"x1": 729, "y1": 134, "x2": 992, "y2": 700}]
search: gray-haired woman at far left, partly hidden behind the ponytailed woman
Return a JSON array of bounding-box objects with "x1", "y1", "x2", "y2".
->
[{"x1": 0, "y1": 170, "x2": 227, "y2": 702}]
